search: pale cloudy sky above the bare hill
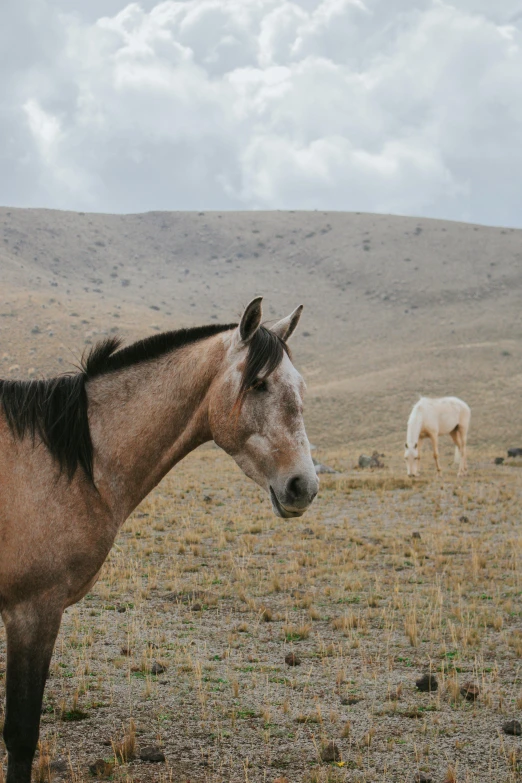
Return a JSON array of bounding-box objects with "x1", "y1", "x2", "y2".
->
[{"x1": 0, "y1": 0, "x2": 522, "y2": 227}]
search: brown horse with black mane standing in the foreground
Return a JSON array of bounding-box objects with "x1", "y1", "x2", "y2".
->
[{"x1": 0, "y1": 297, "x2": 318, "y2": 783}]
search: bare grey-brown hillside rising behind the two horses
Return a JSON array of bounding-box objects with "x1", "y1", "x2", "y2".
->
[{"x1": 0, "y1": 208, "x2": 522, "y2": 454}]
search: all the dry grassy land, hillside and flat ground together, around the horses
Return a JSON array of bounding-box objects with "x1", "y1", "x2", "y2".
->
[{"x1": 0, "y1": 205, "x2": 522, "y2": 783}]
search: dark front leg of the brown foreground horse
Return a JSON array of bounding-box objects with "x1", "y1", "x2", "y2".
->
[{"x1": 2, "y1": 601, "x2": 62, "y2": 783}]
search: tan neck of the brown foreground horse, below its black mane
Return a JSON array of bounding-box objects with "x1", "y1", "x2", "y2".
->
[{"x1": 88, "y1": 336, "x2": 224, "y2": 522}]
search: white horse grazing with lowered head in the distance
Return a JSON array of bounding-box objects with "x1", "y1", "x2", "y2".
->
[{"x1": 404, "y1": 397, "x2": 471, "y2": 476}]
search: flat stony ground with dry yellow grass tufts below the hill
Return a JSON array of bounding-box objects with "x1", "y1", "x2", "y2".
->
[{"x1": 0, "y1": 447, "x2": 522, "y2": 783}]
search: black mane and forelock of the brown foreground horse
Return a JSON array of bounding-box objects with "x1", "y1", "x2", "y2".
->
[{"x1": 0, "y1": 324, "x2": 287, "y2": 481}]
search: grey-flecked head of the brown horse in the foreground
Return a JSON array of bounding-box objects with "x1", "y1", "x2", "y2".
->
[{"x1": 209, "y1": 297, "x2": 319, "y2": 518}]
